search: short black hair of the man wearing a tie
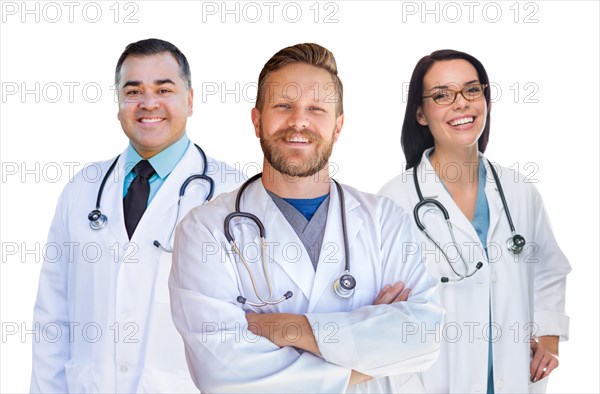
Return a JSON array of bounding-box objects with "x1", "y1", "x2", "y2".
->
[{"x1": 115, "y1": 38, "x2": 192, "y2": 90}]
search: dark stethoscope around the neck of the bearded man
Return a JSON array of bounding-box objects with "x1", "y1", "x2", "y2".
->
[{"x1": 224, "y1": 173, "x2": 356, "y2": 307}]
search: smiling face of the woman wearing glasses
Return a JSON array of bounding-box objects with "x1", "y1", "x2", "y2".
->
[{"x1": 417, "y1": 59, "x2": 488, "y2": 154}]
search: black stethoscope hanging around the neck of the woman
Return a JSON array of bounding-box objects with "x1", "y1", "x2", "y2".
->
[{"x1": 413, "y1": 160, "x2": 525, "y2": 283}]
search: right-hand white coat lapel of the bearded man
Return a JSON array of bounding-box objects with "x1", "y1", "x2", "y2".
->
[{"x1": 308, "y1": 182, "x2": 363, "y2": 312}]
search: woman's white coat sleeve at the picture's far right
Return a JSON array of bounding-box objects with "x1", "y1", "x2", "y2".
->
[{"x1": 530, "y1": 185, "x2": 571, "y2": 341}]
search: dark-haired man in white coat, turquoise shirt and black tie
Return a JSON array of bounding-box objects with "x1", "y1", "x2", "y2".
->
[{"x1": 31, "y1": 39, "x2": 243, "y2": 393}]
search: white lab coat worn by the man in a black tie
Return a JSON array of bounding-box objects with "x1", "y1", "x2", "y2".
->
[{"x1": 31, "y1": 144, "x2": 244, "y2": 393}]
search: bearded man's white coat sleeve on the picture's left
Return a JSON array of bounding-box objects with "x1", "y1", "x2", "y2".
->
[{"x1": 169, "y1": 214, "x2": 351, "y2": 393}]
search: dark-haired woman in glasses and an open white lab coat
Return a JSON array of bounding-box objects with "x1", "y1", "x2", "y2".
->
[{"x1": 380, "y1": 50, "x2": 571, "y2": 393}]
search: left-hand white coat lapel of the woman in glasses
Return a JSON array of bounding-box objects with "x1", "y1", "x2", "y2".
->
[{"x1": 418, "y1": 153, "x2": 479, "y2": 245}]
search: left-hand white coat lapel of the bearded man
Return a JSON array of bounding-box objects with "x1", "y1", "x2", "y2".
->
[{"x1": 246, "y1": 180, "x2": 315, "y2": 299}]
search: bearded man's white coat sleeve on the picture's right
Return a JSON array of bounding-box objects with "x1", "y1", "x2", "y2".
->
[{"x1": 307, "y1": 199, "x2": 444, "y2": 378}]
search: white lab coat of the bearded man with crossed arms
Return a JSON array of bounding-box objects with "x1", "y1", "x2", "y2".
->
[{"x1": 169, "y1": 181, "x2": 443, "y2": 393}]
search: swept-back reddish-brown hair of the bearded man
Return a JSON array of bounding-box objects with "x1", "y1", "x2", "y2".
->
[{"x1": 255, "y1": 43, "x2": 344, "y2": 116}]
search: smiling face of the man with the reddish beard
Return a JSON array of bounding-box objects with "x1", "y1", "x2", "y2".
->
[{"x1": 252, "y1": 63, "x2": 344, "y2": 177}]
